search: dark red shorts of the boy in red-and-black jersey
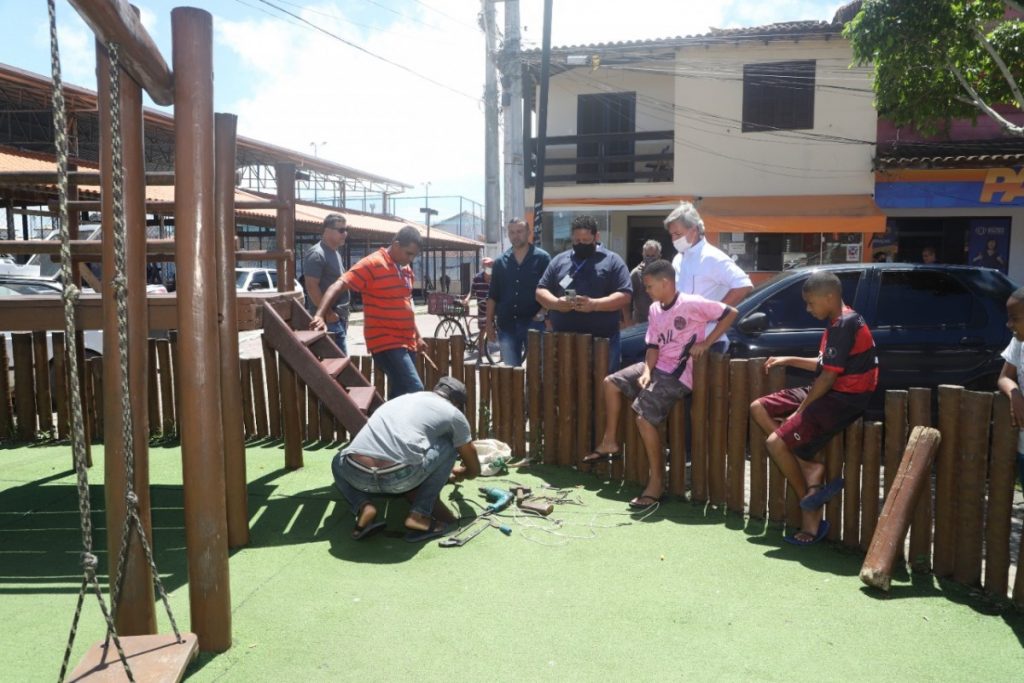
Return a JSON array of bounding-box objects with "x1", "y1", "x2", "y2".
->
[{"x1": 758, "y1": 386, "x2": 871, "y2": 460}]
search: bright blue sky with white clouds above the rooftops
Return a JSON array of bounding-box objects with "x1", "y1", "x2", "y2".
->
[{"x1": 0, "y1": 0, "x2": 844, "y2": 219}]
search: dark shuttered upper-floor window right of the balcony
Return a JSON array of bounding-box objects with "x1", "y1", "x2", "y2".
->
[{"x1": 743, "y1": 59, "x2": 815, "y2": 133}]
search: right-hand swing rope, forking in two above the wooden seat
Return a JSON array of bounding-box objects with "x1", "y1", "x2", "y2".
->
[{"x1": 106, "y1": 43, "x2": 182, "y2": 643}]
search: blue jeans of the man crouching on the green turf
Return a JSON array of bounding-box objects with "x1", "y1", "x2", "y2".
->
[{"x1": 331, "y1": 441, "x2": 459, "y2": 517}]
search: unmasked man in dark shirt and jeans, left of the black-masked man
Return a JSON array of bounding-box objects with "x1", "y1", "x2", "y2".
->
[{"x1": 485, "y1": 218, "x2": 551, "y2": 367}]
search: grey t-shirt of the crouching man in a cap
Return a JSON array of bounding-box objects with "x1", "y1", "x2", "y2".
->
[{"x1": 341, "y1": 391, "x2": 473, "y2": 465}]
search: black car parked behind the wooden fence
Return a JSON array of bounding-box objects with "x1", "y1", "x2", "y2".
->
[{"x1": 728, "y1": 263, "x2": 1016, "y2": 413}]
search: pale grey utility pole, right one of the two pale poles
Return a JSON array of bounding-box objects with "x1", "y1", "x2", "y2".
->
[{"x1": 502, "y1": 0, "x2": 526, "y2": 232}]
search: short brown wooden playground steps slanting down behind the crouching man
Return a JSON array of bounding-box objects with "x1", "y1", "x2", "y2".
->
[{"x1": 263, "y1": 301, "x2": 384, "y2": 435}]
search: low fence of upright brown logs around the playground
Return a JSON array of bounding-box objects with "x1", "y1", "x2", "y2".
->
[{"x1": 0, "y1": 333, "x2": 1024, "y2": 607}]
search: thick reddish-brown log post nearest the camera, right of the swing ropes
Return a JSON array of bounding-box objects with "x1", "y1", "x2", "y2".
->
[{"x1": 173, "y1": 7, "x2": 231, "y2": 651}]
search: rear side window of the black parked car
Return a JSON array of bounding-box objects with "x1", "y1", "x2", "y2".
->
[{"x1": 878, "y1": 270, "x2": 986, "y2": 329}]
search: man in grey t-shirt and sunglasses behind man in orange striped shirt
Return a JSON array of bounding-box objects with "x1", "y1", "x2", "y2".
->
[{"x1": 302, "y1": 213, "x2": 351, "y2": 355}]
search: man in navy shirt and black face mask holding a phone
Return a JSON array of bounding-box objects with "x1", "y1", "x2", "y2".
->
[{"x1": 537, "y1": 216, "x2": 633, "y2": 373}]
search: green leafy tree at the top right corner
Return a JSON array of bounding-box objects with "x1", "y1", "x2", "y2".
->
[{"x1": 844, "y1": 0, "x2": 1024, "y2": 136}]
